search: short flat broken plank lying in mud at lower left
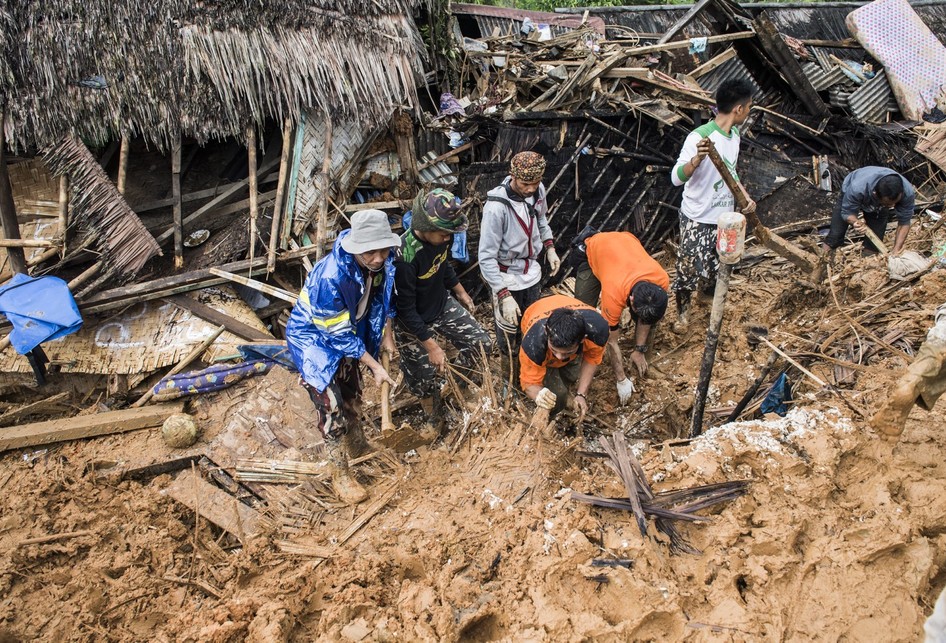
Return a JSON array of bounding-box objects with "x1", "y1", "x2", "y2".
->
[{"x1": 164, "y1": 470, "x2": 262, "y2": 542}]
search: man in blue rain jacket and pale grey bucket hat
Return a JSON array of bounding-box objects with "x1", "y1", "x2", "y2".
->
[{"x1": 286, "y1": 210, "x2": 401, "y2": 504}]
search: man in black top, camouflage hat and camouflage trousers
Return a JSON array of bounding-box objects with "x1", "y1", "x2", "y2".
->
[{"x1": 394, "y1": 188, "x2": 492, "y2": 432}]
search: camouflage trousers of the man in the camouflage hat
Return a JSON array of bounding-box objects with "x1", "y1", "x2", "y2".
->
[{"x1": 394, "y1": 296, "x2": 493, "y2": 398}]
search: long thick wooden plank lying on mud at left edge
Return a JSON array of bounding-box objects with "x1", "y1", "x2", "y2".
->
[{"x1": 0, "y1": 402, "x2": 184, "y2": 452}]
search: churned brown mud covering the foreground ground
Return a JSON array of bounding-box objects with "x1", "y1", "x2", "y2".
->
[{"x1": 0, "y1": 244, "x2": 946, "y2": 642}]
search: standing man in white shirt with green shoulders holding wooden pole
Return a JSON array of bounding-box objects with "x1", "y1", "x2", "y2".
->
[{"x1": 670, "y1": 79, "x2": 755, "y2": 332}]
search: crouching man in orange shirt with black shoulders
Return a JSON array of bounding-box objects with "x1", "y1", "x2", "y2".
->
[{"x1": 519, "y1": 295, "x2": 608, "y2": 422}]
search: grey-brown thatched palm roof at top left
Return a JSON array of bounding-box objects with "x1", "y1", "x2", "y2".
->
[{"x1": 0, "y1": 0, "x2": 423, "y2": 149}]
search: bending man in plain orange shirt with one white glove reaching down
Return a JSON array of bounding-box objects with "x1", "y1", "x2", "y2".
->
[{"x1": 573, "y1": 232, "x2": 670, "y2": 404}]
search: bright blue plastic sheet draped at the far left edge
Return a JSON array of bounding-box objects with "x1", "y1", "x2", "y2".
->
[{"x1": 0, "y1": 274, "x2": 82, "y2": 355}]
